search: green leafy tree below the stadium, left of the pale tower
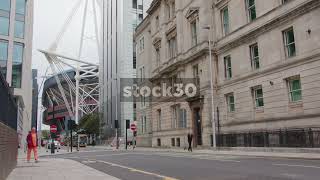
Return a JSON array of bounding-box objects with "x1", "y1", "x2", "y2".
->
[{"x1": 79, "y1": 113, "x2": 100, "y2": 134}]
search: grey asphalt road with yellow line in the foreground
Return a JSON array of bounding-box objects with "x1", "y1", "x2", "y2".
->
[{"x1": 45, "y1": 150, "x2": 320, "y2": 180}]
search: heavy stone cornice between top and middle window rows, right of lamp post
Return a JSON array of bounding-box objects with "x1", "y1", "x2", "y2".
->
[{"x1": 215, "y1": 0, "x2": 320, "y2": 54}]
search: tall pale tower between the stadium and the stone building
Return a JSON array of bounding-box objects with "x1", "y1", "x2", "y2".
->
[{"x1": 100, "y1": 0, "x2": 152, "y2": 138}]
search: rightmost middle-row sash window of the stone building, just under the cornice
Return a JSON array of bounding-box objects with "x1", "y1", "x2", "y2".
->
[{"x1": 283, "y1": 27, "x2": 296, "y2": 57}]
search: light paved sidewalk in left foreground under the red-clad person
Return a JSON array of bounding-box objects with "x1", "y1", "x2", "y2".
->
[{"x1": 7, "y1": 149, "x2": 119, "y2": 180}]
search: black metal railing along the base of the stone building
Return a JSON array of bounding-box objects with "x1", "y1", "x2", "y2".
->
[{"x1": 217, "y1": 128, "x2": 320, "y2": 148}]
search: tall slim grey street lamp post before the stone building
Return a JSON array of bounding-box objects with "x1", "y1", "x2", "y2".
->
[{"x1": 203, "y1": 26, "x2": 217, "y2": 148}]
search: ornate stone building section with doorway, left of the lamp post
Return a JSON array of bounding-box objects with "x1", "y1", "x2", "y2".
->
[{"x1": 135, "y1": 0, "x2": 212, "y2": 147}]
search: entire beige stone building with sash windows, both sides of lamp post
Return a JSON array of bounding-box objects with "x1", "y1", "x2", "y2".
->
[{"x1": 135, "y1": 0, "x2": 320, "y2": 147}]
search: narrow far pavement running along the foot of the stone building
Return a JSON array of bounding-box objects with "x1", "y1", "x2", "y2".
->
[{"x1": 90, "y1": 146, "x2": 320, "y2": 160}]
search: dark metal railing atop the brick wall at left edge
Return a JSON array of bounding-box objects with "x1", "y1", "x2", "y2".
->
[{"x1": 0, "y1": 72, "x2": 17, "y2": 130}]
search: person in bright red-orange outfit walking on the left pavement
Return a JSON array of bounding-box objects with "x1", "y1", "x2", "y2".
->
[{"x1": 27, "y1": 127, "x2": 38, "y2": 163}]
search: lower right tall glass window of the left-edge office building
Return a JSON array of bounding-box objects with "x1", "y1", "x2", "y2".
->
[{"x1": 12, "y1": 43, "x2": 24, "y2": 88}]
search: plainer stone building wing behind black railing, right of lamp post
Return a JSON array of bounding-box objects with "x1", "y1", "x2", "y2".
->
[{"x1": 213, "y1": 0, "x2": 320, "y2": 147}]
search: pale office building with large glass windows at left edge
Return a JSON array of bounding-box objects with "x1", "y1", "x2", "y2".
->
[{"x1": 0, "y1": 0, "x2": 33, "y2": 146}]
